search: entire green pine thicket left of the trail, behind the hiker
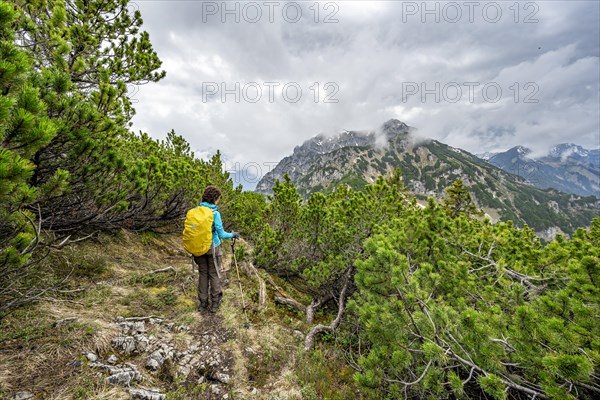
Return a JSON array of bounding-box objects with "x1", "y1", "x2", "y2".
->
[{"x1": 0, "y1": 0, "x2": 264, "y2": 320}]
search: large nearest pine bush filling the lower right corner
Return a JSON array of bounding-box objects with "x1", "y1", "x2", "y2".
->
[{"x1": 346, "y1": 198, "x2": 600, "y2": 399}]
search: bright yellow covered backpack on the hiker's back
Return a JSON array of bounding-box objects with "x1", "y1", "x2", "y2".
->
[{"x1": 183, "y1": 206, "x2": 215, "y2": 256}]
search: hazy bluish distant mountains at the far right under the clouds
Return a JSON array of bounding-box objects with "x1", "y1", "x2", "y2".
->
[{"x1": 478, "y1": 143, "x2": 600, "y2": 197}]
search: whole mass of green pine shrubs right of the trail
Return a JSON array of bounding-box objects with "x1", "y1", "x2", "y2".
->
[{"x1": 254, "y1": 178, "x2": 600, "y2": 399}]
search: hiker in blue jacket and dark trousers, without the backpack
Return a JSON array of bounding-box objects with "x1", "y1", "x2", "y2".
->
[{"x1": 194, "y1": 186, "x2": 240, "y2": 313}]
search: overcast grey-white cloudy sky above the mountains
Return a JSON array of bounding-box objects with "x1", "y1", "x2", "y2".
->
[{"x1": 131, "y1": 0, "x2": 600, "y2": 188}]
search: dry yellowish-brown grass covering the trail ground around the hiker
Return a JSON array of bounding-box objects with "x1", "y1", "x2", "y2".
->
[{"x1": 0, "y1": 231, "x2": 360, "y2": 400}]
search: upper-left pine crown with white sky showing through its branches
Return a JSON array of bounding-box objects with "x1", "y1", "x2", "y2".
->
[{"x1": 14, "y1": 0, "x2": 166, "y2": 124}]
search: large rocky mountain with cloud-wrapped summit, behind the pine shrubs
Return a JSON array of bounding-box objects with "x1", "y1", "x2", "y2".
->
[{"x1": 256, "y1": 119, "x2": 600, "y2": 239}]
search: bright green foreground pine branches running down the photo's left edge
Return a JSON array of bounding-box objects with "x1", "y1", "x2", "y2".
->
[{"x1": 0, "y1": 2, "x2": 56, "y2": 317}]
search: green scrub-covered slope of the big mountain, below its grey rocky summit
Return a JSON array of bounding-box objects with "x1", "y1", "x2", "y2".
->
[{"x1": 282, "y1": 136, "x2": 599, "y2": 235}]
